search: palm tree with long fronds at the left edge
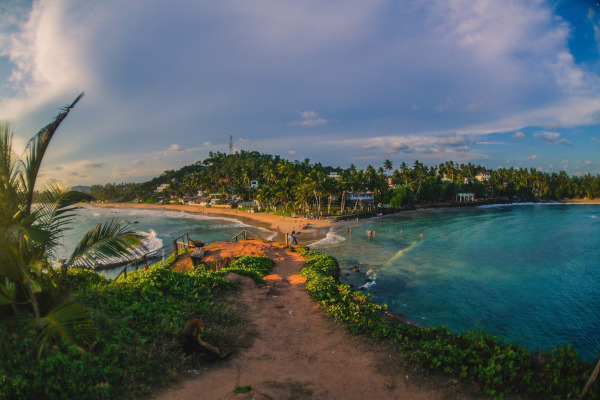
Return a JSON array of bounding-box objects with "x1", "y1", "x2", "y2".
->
[{"x1": 0, "y1": 93, "x2": 141, "y2": 351}]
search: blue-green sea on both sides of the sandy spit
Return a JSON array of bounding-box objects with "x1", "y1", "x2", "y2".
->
[{"x1": 61, "y1": 203, "x2": 600, "y2": 361}]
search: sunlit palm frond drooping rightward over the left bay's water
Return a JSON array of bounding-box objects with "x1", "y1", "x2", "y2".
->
[{"x1": 67, "y1": 219, "x2": 145, "y2": 268}]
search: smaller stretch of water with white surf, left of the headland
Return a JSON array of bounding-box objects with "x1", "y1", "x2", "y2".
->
[{"x1": 56, "y1": 206, "x2": 274, "y2": 277}]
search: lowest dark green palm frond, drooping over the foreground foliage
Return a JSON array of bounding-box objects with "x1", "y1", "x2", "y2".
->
[{"x1": 38, "y1": 301, "x2": 98, "y2": 353}]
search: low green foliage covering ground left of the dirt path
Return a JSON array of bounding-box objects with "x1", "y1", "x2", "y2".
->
[{"x1": 0, "y1": 257, "x2": 270, "y2": 399}]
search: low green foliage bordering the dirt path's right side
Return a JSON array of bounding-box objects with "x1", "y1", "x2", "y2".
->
[{"x1": 302, "y1": 250, "x2": 600, "y2": 399}]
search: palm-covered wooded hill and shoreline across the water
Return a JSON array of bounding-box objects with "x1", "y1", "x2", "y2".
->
[{"x1": 92, "y1": 151, "x2": 600, "y2": 211}]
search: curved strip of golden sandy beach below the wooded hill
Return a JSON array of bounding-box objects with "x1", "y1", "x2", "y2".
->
[{"x1": 92, "y1": 203, "x2": 336, "y2": 245}]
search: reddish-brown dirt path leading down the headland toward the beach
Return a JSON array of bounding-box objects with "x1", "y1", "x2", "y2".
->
[{"x1": 156, "y1": 241, "x2": 476, "y2": 400}]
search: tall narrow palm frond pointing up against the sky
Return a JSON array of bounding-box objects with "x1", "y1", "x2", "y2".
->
[{"x1": 24, "y1": 93, "x2": 83, "y2": 208}]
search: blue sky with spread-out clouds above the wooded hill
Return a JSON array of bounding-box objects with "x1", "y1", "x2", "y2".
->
[{"x1": 0, "y1": 0, "x2": 600, "y2": 186}]
